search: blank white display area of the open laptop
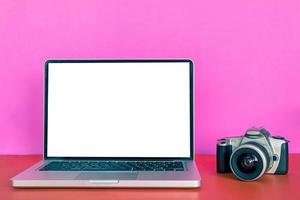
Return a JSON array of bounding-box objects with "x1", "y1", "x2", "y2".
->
[{"x1": 47, "y1": 62, "x2": 190, "y2": 157}]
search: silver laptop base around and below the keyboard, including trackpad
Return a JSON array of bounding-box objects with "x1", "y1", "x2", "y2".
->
[{"x1": 11, "y1": 161, "x2": 201, "y2": 188}]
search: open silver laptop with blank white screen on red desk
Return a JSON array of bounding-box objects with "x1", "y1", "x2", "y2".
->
[{"x1": 11, "y1": 59, "x2": 201, "y2": 188}]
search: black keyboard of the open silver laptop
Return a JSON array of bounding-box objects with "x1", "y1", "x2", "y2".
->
[{"x1": 40, "y1": 161, "x2": 184, "y2": 171}]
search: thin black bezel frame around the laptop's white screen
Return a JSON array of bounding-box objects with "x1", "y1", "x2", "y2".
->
[{"x1": 44, "y1": 59, "x2": 194, "y2": 160}]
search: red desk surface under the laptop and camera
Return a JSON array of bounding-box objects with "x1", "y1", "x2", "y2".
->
[{"x1": 0, "y1": 154, "x2": 300, "y2": 200}]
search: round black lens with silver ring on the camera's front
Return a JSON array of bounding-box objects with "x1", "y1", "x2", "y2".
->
[{"x1": 230, "y1": 143, "x2": 270, "y2": 181}]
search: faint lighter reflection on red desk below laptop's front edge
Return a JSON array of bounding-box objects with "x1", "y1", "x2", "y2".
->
[{"x1": 12, "y1": 188, "x2": 201, "y2": 200}]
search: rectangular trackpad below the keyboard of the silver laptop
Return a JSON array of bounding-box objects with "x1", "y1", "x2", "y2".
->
[{"x1": 75, "y1": 172, "x2": 138, "y2": 180}]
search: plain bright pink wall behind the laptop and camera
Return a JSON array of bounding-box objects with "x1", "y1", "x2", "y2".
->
[{"x1": 0, "y1": 0, "x2": 300, "y2": 154}]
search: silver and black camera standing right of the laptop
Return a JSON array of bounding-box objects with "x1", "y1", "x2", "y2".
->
[{"x1": 217, "y1": 128, "x2": 288, "y2": 181}]
